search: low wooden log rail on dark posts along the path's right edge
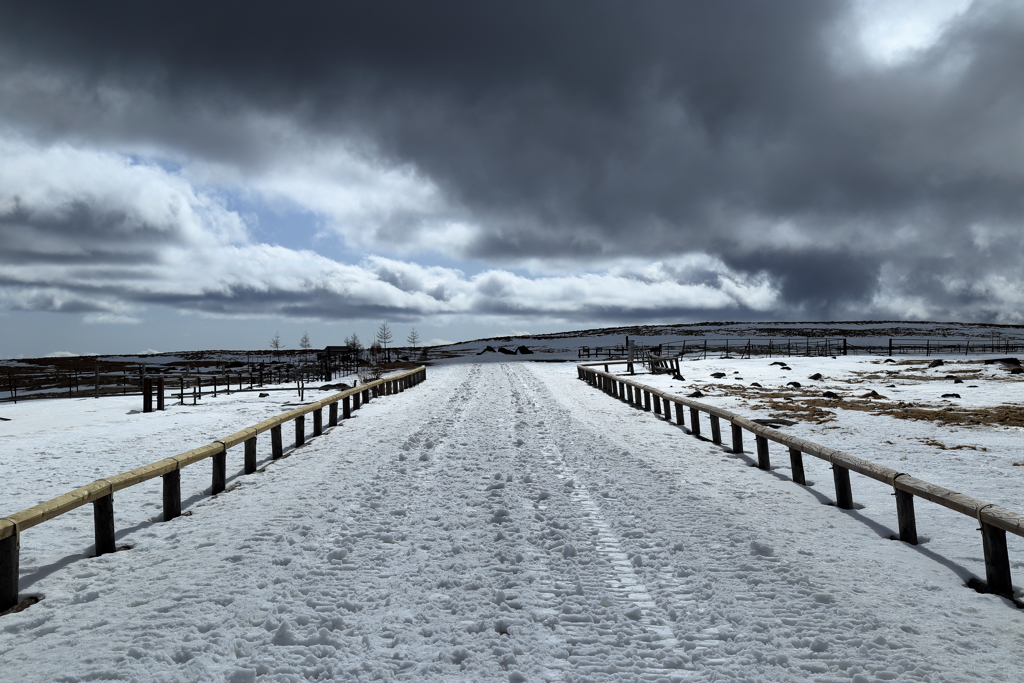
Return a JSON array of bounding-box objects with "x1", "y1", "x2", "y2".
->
[{"x1": 577, "y1": 360, "x2": 1024, "y2": 598}]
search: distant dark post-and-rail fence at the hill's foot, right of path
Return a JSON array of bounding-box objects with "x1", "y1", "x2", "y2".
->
[{"x1": 577, "y1": 337, "x2": 1024, "y2": 360}]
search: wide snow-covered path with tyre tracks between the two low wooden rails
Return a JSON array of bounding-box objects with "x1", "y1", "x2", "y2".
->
[{"x1": 0, "y1": 364, "x2": 1024, "y2": 683}]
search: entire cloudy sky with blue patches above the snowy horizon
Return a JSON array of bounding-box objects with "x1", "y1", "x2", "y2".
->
[{"x1": 0, "y1": 0, "x2": 1024, "y2": 357}]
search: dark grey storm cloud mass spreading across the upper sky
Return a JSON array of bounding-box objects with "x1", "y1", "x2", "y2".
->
[{"x1": 0, "y1": 0, "x2": 1024, "y2": 315}]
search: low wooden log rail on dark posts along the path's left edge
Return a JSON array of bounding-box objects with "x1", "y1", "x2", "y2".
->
[{"x1": 0, "y1": 366, "x2": 426, "y2": 612}]
